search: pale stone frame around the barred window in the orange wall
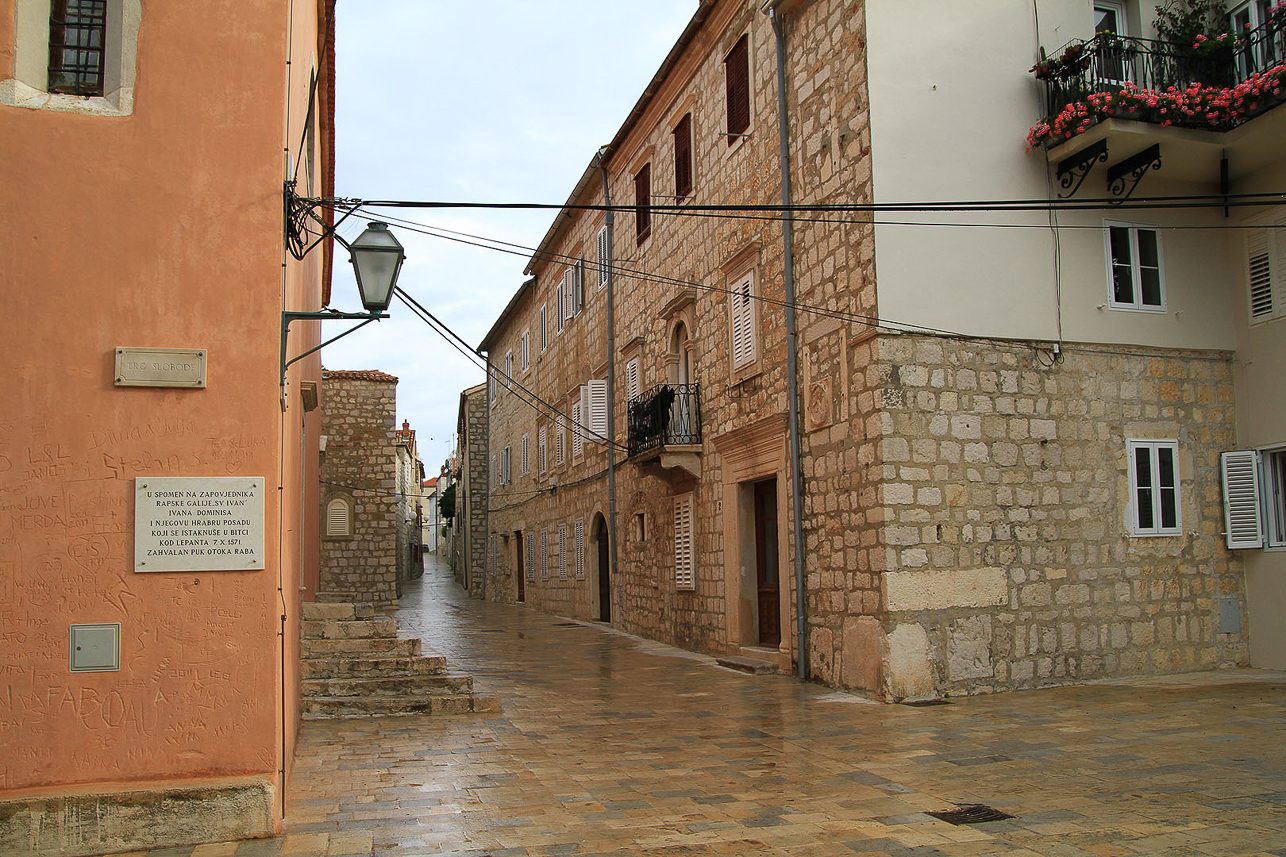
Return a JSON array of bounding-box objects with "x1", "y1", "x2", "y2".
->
[{"x1": 0, "y1": 0, "x2": 143, "y2": 116}]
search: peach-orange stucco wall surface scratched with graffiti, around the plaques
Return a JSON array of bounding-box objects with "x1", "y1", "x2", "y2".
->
[{"x1": 0, "y1": 0, "x2": 320, "y2": 813}]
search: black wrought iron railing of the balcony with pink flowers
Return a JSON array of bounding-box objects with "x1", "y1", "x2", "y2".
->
[{"x1": 1033, "y1": 13, "x2": 1286, "y2": 130}]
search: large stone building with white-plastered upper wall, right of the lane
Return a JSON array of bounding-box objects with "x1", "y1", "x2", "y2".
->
[{"x1": 482, "y1": 0, "x2": 1286, "y2": 699}]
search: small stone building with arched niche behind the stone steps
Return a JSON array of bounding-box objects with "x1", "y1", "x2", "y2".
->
[{"x1": 318, "y1": 369, "x2": 401, "y2": 609}]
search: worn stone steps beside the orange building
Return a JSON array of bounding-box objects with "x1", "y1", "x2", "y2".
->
[{"x1": 300, "y1": 604, "x2": 500, "y2": 721}]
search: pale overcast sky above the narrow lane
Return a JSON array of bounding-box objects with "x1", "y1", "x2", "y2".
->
[{"x1": 323, "y1": 0, "x2": 697, "y2": 477}]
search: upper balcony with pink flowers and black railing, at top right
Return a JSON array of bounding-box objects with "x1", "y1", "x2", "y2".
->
[{"x1": 1028, "y1": 1, "x2": 1286, "y2": 190}]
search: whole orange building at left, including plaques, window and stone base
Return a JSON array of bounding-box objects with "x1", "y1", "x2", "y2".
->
[{"x1": 0, "y1": 0, "x2": 336, "y2": 857}]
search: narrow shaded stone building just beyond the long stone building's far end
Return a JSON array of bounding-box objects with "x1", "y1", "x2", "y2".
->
[{"x1": 451, "y1": 383, "x2": 494, "y2": 597}]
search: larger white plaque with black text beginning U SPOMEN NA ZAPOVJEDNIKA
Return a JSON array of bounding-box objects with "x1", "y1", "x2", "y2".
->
[{"x1": 134, "y1": 476, "x2": 264, "y2": 571}]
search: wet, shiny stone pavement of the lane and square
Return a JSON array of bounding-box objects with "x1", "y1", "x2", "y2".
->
[{"x1": 115, "y1": 553, "x2": 1286, "y2": 857}]
